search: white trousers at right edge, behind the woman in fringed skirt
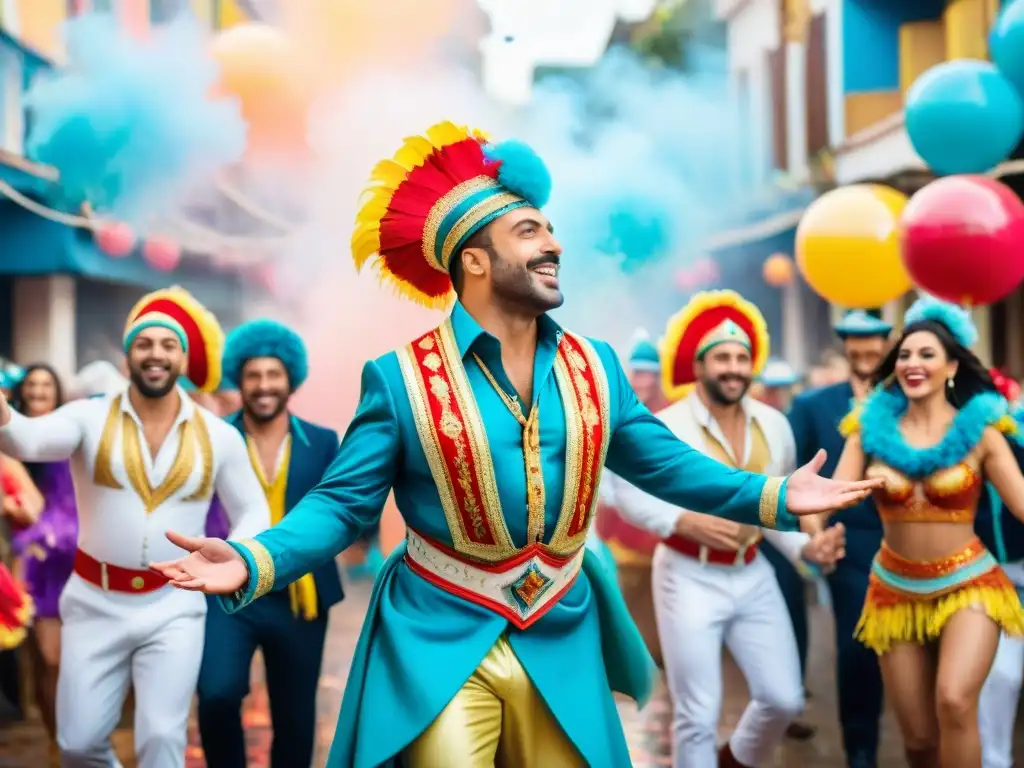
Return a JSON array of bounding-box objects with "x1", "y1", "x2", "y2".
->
[{"x1": 978, "y1": 562, "x2": 1024, "y2": 768}]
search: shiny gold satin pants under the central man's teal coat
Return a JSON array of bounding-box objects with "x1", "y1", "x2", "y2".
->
[{"x1": 402, "y1": 636, "x2": 587, "y2": 768}]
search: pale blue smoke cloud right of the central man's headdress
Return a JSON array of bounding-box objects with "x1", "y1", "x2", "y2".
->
[{"x1": 511, "y1": 48, "x2": 751, "y2": 343}]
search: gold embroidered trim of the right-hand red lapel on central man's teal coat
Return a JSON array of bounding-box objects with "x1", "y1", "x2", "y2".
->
[{"x1": 548, "y1": 332, "x2": 611, "y2": 555}]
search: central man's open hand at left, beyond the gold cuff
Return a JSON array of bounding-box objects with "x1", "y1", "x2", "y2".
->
[{"x1": 150, "y1": 530, "x2": 249, "y2": 595}]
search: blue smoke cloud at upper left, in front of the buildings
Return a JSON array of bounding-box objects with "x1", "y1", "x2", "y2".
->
[{"x1": 27, "y1": 14, "x2": 246, "y2": 226}]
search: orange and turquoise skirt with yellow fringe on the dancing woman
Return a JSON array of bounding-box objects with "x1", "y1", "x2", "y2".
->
[{"x1": 855, "y1": 539, "x2": 1024, "y2": 655}]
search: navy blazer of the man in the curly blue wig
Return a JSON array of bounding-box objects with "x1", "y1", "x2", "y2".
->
[{"x1": 226, "y1": 411, "x2": 345, "y2": 615}]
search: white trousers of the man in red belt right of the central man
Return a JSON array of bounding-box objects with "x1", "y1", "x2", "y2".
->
[{"x1": 652, "y1": 545, "x2": 804, "y2": 768}]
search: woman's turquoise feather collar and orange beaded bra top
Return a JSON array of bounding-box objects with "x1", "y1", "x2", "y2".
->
[{"x1": 840, "y1": 389, "x2": 1020, "y2": 524}]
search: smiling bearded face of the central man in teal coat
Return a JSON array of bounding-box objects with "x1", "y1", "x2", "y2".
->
[{"x1": 461, "y1": 208, "x2": 564, "y2": 314}]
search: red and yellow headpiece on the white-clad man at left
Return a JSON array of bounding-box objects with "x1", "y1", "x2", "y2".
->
[{"x1": 124, "y1": 286, "x2": 224, "y2": 392}]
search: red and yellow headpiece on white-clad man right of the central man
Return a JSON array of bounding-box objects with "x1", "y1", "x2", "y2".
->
[{"x1": 662, "y1": 291, "x2": 769, "y2": 400}]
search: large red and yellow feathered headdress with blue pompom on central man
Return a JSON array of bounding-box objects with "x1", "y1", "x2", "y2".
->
[{"x1": 352, "y1": 122, "x2": 551, "y2": 307}]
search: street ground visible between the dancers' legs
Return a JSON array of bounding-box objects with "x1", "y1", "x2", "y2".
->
[{"x1": 0, "y1": 584, "x2": 1024, "y2": 768}]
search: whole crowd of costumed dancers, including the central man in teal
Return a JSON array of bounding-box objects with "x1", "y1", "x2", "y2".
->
[{"x1": 0, "y1": 115, "x2": 1024, "y2": 768}]
